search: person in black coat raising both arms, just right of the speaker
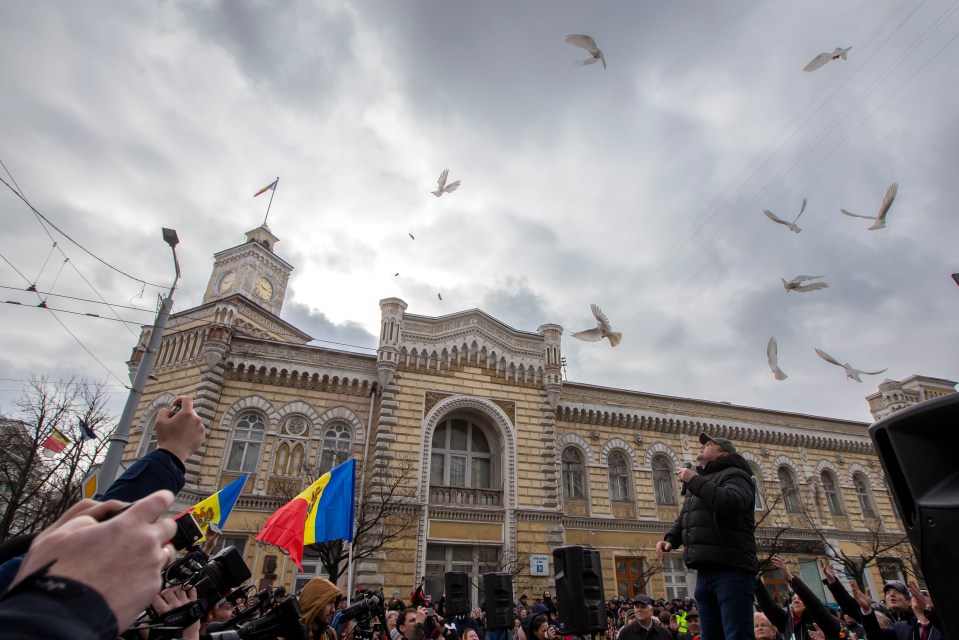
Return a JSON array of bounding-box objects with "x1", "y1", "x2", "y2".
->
[{"x1": 756, "y1": 555, "x2": 842, "y2": 640}]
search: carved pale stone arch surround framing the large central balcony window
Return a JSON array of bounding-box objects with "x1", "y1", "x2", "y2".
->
[{"x1": 414, "y1": 398, "x2": 518, "y2": 567}]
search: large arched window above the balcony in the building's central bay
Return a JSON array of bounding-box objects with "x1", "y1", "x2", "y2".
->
[{"x1": 430, "y1": 418, "x2": 493, "y2": 489}]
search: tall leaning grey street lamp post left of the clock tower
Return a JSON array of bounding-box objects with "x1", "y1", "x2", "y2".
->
[{"x1": 97, "y1": 228, "x2": 180, "y2": 494}]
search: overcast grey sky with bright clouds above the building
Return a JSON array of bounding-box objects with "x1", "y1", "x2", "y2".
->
[{"x1": 0, "y1": 0, "x2": 959, "y2": 428}]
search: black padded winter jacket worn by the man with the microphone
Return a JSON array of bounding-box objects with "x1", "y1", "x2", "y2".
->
[{"x1": 664, "y1": 453, "x2": 759, "y2": 574}]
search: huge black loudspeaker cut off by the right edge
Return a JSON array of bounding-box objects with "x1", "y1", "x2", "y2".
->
[{"x1": 869, "y1": 394, "x2": 959, "y2": 638}]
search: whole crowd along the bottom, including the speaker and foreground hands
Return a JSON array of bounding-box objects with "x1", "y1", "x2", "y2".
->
[{"x1": 0, "y1": 397, "x2": 945, "y2": 640}]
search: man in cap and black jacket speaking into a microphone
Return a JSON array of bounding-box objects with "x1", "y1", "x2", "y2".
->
[{"x1": 656, "y1": 433, "x2": 759, "y2": 640}]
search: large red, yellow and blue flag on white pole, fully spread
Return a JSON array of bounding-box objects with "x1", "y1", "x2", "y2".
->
[{"x1": 256, "y1": 460, "x2": 356, "y2": 571}]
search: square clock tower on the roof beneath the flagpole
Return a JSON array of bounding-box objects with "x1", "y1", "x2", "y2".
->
[{"x1": 203, "y1": 224, "x2": 293, "y2": 316}]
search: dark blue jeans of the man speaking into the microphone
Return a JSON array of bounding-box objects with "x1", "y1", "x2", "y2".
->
[{"x1": 696, "y1": 569, "x2": 756, "y2": 640}]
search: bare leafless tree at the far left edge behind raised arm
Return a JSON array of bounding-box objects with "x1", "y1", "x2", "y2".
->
[{"x1": 0, "y1": 377, "x2": 116, "y2": 540}]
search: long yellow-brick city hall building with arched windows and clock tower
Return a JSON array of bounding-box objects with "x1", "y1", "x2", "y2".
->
[{"x1": 124, "y1": 225, "x2": 955, "y2": 603}]
